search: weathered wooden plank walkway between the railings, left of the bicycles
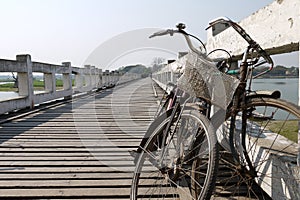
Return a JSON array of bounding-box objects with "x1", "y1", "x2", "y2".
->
[{"x1": 0, "y1": 78, "x2": 157, "y2": 199}]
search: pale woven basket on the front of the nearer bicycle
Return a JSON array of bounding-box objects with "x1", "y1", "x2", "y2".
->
[{"x1": 178, "y1": 53, "x2": 239, "y2": 108}]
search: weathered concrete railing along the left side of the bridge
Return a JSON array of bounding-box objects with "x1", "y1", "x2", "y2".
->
[{"x1": 0, "y1": 55, "x2": 140, "y2": 114}]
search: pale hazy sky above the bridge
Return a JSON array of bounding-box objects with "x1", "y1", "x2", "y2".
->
[{"x1": 0, "y1": 0, "x2": 298, "y2": 68}]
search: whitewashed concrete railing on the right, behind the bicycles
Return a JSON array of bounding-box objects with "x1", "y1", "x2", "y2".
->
[{"x1": 152, "y1": 0, "x2": 300, "y2": 199}]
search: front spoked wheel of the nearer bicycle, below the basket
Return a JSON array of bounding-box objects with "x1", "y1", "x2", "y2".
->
[{"x1": 131, "y1": 110, "x2": 218, "y2": 200}]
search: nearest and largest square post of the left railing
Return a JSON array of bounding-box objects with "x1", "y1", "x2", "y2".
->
[{"x1": 16, "y1": 54, "x2": 34, "y2": 109}]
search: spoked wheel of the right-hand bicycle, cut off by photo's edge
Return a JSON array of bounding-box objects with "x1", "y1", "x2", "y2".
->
[{"x1": 215, "y1": 98, "x2": 300, "y2": 199}]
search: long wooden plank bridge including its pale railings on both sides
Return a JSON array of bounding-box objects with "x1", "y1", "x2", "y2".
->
[{"x1": 0, "y1": 0, "x2": 300, "y2": 199}]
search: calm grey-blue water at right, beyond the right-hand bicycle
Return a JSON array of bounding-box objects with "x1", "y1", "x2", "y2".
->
[{"x1": 252, "y1": 78, "x2": 299, "y2": 105}]
